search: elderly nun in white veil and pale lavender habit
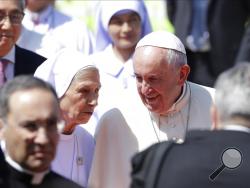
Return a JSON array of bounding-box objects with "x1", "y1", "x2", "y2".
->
[{"x1": 34, "y1": 49, "x2": 100, "y2": 187}]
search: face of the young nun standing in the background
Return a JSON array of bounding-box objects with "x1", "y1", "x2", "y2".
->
[{"x1": 108, "y1": 11, "x2": 142, "y2": 50}]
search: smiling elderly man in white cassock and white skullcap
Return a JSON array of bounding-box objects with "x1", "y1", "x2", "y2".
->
[{"x1": 89, "y1": 31, "x2": 215, "y2": 188}]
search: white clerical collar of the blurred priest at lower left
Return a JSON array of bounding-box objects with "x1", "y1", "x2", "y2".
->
[{"x1": 0, "y1": 140, "x2": 49, "y2": 185}]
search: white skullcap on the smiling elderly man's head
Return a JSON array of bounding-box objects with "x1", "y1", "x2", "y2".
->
[{"x1": 136, "y1": 31, "x2": 186, "y2": 54}]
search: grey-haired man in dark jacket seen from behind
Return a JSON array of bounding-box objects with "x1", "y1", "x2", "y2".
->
[{"x1": 131, "y1": 63, "x2": 250, "y2": 188}]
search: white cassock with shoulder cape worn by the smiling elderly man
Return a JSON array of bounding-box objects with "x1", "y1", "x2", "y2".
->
[{"x1": 88, "y1": 82, "x2": 215, "y2": 188}]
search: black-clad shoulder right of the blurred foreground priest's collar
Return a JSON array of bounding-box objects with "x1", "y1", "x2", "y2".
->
[{"x1": 44, "y1": 171, "x2": 82, "y2": 188}]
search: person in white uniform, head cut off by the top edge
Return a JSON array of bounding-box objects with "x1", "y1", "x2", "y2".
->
[{"x1": 18, "y1": 0, "x2": 93, "y2": 58}]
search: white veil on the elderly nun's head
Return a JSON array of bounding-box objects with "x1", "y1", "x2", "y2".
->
[{"x1": 34, "y1": 48, "x2": 96, "y2": 98}]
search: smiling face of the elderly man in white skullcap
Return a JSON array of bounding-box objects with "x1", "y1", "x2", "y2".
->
[{"x1": 133, "y1": 46, "x2": 189, "y2": 114}]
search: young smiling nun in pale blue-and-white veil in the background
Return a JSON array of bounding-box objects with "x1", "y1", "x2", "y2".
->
[{"x1": 85, "y1": 0, "x2": 152, "y2": 135}]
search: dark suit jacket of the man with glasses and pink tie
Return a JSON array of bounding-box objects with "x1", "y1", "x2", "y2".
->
[{"x1": 14, "y1": 45, "x2": 46, "y2": 76}]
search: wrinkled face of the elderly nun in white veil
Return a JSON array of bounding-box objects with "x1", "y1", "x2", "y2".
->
[{"x1": 60, "y1": 68, "x2": 101, "y2": 126}]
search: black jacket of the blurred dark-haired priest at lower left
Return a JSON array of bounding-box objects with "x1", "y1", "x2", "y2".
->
[{"x1": 0, "y1": 149, "x2": 81, "y2": 188}]
